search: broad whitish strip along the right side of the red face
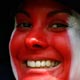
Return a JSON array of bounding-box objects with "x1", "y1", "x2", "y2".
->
[{"x1": 68, "y1": 11, "x2": 80, "y2": 80}]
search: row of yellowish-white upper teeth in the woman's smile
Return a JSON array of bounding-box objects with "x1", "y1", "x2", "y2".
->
[{"x1": 26, "y1": 60, "x2": 59, "y2": 68}]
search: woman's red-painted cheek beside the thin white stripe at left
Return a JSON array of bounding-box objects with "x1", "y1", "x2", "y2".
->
[{"x1": 9, "y1": 31, "x2": 25, "y2": 56}]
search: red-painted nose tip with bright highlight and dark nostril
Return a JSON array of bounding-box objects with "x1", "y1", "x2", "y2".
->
[{"x1": 25, "y1": 37, "x2": 48, "y2": 49}]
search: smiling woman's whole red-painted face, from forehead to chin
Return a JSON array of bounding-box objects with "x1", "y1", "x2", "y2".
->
[{"x1": 9, "y1": 0, "x2": 80, "y2": 80}]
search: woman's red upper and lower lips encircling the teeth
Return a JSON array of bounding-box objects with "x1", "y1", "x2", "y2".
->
[{"x1": 19, "y1": 57, "x2": 63, "y2": 74}]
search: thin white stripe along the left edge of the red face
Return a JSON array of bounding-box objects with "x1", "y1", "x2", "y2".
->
[{"x1": 9, "y1": 20, "x2": 18, "y2": 80}]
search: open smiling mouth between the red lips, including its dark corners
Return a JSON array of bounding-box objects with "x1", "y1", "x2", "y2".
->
[{"x1": 23, "y1": 60, "x2": 61, "y2": 68}]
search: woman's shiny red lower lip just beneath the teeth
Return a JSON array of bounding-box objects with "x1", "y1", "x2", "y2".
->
[{"x1": 25, "y1": 64, "x2": 62, "y2": 75}]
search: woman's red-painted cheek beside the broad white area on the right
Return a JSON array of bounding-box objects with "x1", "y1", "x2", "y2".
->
[{"x1": 50, "y1": 31, "x2": 71, "y2": 59}]
